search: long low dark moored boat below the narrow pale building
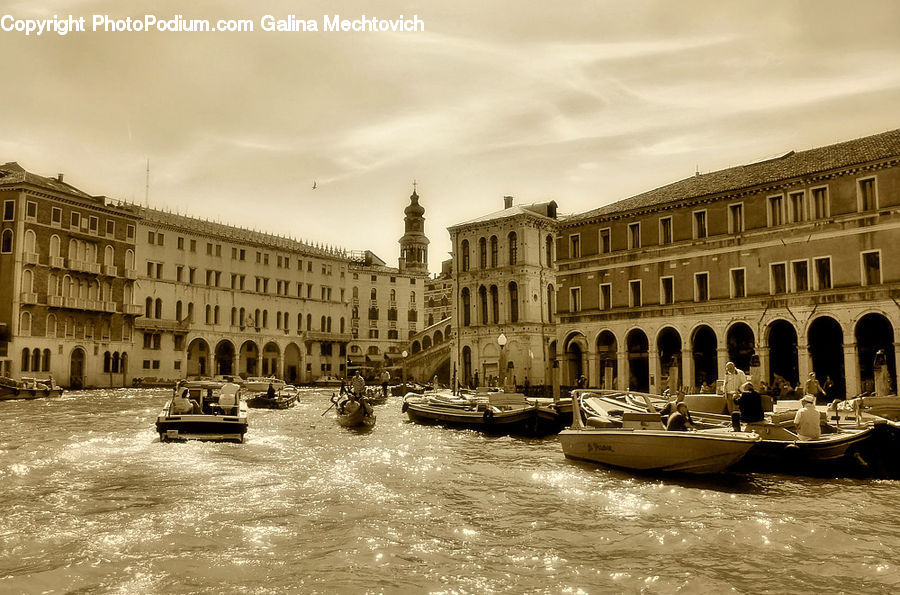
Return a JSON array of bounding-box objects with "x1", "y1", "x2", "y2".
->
[{"x1": 401, "y1": 390, "x2": 545, "y2": 435}]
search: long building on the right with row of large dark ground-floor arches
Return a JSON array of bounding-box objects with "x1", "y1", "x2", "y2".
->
[{"x1": 553, "y1": 130, "x2": 900, "y2": 396}]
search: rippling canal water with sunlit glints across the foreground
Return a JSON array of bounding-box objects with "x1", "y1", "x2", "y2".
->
[{"x1": 0, "y1": 389, "x2": 900, "y2": 593}]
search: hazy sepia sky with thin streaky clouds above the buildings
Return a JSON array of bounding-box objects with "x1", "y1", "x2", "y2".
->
[{"x1": 0, "y1": 0, "x2": 900, "y2": 272}]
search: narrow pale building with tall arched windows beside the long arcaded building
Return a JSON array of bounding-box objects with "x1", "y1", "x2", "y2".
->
[{"x1": 448, "y1": 197, "x2": 558, "y2": 385}]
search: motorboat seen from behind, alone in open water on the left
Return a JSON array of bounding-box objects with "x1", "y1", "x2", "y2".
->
[{"x1": 156, "y1": 380, "x2": 248, "y2": 442}]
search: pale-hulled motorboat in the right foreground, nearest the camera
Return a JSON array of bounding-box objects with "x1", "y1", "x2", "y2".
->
[{"x1": 559, "y1": 395, "x2": 760, "y2": 474}]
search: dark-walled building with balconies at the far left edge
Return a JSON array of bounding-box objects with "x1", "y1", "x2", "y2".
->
[{"x1": 0, "y1": 163, "x2": 139, "y2": 388}]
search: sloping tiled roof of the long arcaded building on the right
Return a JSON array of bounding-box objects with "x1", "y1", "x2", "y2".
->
[{"x1": 566, "y1": 129, "x2": 900, "y2": 223}]
